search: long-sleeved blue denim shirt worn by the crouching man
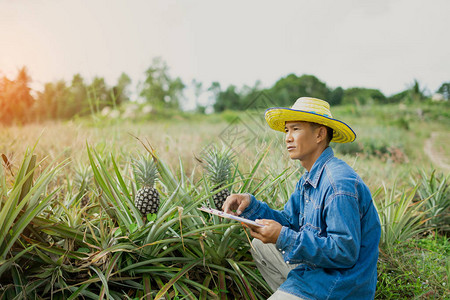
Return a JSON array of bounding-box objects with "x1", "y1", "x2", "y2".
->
[{"x1": 242, "y1": 147, "x2": 381, "y2": 300}]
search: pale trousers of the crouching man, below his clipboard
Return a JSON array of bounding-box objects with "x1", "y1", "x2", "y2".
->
[{"x1": 251, "y1": 239, "x2": 302, "y2": 300}]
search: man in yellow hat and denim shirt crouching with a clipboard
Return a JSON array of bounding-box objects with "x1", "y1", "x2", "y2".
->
[{"x1": 223, "y1": 97, "x2": 381, "y2": 300}]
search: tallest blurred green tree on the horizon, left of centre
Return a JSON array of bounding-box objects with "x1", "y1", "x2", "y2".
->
[{"x1": 140, "y1": 57, "x2": 185, "y2": 109}]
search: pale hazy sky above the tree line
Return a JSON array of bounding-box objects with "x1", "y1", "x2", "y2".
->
[{"x1": 0, "y1": 0, "x2": 450, "y2": 108}]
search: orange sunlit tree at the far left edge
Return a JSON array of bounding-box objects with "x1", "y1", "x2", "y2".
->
[{"x1": 0, "y1": 67, "x2": 34, "y2": 124}]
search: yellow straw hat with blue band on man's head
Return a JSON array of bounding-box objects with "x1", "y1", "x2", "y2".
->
[{"x1": 265, "y1": 97, "x2": 356, "y2": 143}]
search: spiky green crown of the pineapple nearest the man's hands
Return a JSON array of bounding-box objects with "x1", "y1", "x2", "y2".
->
[{"x1": 202, "y1": 147, "x2": 234, "y2": 186}]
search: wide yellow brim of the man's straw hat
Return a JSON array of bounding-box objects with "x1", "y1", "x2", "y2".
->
[{"x1": 265, "y1": 107, "x2": 356, "y2": 143}]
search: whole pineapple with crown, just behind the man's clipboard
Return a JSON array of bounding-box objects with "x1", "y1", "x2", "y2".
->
[{"x1": 202, "y1": 148, "x2": 234, "y2": 209}]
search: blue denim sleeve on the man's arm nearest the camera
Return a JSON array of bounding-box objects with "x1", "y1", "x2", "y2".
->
[{"x1": 276, "y1": 194, "x2": 361, "y2": 268}]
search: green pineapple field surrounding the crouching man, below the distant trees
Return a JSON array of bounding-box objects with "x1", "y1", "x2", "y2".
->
[{"x1": 0, "y1": 103, "x2": 450, "y2": 300}]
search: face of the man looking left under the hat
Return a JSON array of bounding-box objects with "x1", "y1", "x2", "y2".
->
[{"x1": 284, "y1": 121, "x2": 320, "y2": 165}]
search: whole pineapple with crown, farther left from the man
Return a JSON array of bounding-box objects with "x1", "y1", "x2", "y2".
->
[{"x1": 134, "y1": 156, "x2": 160, "y2": 216}]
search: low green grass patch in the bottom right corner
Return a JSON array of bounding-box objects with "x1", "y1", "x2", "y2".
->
[{"x1": 376, "y1": 234, "x2": 450, "y2": 299}]
